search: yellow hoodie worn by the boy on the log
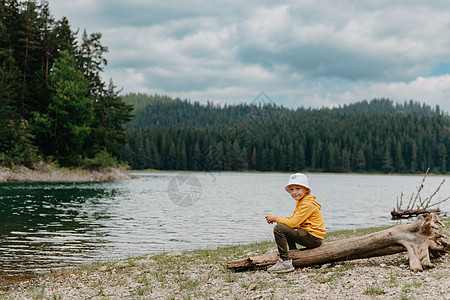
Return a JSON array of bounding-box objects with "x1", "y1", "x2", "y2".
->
[{"x1": 277, "y1": 194, "x2": 326, "y2": 239}]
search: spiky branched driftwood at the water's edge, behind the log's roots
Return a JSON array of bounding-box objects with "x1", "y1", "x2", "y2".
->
[{"x1": 391, "y1": 168, "x2": 450, "y2": 220}]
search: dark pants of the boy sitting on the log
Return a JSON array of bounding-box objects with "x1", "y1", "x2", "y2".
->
[{"x1": 273, "y1": 224, "x2": 322, "y2": 260}]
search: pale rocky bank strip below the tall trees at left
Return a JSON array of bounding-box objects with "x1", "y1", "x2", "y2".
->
[{"x1": 0, "y1": 163, "x2": 134, "y2": 182}]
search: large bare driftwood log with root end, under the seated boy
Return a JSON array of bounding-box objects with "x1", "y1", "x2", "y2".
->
[{"x1": 227, "y1": 214, "x2": 450, "y2": 272}]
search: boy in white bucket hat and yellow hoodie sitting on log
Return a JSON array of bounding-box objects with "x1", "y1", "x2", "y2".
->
[{"x1": 265, "y1": 173, "x2": 326, "y2": 273}]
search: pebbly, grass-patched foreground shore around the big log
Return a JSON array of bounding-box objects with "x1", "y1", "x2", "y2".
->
[{"x1": 0, "y1": 218, "x2": 450, "y2": 300}]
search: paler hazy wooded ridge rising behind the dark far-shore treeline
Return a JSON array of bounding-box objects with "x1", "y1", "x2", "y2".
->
[{"x1": 122, "y1": 94, "x2": 440, "y2": 128}]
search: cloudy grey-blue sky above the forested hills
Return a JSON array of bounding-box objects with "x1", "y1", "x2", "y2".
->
[{"x1": 49, "y1": 0, "x2": 450, "y2": 112}]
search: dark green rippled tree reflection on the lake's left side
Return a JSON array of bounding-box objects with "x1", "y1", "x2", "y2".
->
[{"x1": 0, "y1": 183, "x2": 116, "y2": 276}]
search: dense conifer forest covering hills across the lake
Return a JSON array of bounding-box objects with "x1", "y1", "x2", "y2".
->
[{"x1": 120, "y1": 94, "x2": 450, "y2": 173}]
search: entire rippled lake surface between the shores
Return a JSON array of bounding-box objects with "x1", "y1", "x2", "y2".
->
[{"x1": 0, "y1": 172, "x2": 450, "y2": 278}]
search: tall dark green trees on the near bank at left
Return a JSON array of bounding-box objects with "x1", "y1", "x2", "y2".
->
[{"x1": 0, "y1": 0, "x2": 132, "y2": 167}]
